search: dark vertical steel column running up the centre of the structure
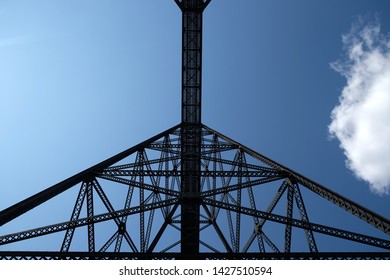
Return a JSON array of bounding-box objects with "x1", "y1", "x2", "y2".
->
[{"x1": 176, "y1": 0, "x2": 209, "y2": 255}]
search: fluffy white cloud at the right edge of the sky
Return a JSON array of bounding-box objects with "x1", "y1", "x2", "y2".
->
[{"x1": 329, "y1": 21, "x2": 390, "y2": 194}]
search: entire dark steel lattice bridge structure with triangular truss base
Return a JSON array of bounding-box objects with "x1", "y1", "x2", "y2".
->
[{"x1": 0, "y1": 0, "x2": 390, "y2": 259}]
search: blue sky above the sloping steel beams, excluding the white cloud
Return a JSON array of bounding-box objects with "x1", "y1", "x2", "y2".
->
[{"x1": 0, "y1": 0, "x2": 390, "y2": 253}]
